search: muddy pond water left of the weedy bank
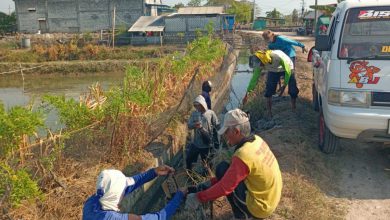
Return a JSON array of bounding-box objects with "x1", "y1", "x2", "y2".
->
[{"x1": 0, "y1": 73, "x2": 124, "y2": 130}]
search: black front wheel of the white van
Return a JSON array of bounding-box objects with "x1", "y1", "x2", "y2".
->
[{"x1": 318, "y1": 110, "x2": 340, "y2": 154}]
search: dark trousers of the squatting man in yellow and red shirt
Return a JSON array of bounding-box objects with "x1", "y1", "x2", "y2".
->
[{"x1": 215, "y1": 161, "x2": 253, "y2": 219}]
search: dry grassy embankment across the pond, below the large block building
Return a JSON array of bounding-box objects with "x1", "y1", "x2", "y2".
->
[{"x1": 0, "y1": 40, "x2": 184, "y2": 74}]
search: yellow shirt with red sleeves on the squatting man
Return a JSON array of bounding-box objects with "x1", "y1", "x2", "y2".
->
[{"x1": 196, "y1": 135, "x2": 283, "y2": 218}]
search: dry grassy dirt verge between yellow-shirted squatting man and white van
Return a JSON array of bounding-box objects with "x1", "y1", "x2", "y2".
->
[{"x1": 259, "y1": 45, "x2": 346, "y2": 220}]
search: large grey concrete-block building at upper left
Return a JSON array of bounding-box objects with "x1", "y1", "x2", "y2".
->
[{"x1": 14, "y1": 0, "x2": 165, "y2": 33}]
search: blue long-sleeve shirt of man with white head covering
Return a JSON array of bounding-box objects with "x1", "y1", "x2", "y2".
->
[{"x1": 83, "y1": 169, "x2": 184, "y2": 220}]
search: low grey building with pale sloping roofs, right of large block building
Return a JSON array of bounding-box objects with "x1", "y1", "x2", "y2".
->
[{"x1": 128, "y1": 6, "x2": 235, "y2": 45}]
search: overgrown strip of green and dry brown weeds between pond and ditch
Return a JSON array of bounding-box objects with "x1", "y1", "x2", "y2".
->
[{"x1": 0, "y1": 35, "x2": 225, "y2": 219}]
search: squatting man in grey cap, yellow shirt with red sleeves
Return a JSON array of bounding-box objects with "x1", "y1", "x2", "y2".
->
[{"x1": 185, "y1": 109, "x2": 283, "y2": 219}]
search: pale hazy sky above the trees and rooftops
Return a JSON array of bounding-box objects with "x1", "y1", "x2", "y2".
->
[{"x1": 0, "y1": 0, "x2": 337, "y2": 15}]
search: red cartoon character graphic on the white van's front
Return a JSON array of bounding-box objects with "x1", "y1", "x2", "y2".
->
[{"x1": 348, "y1": 61, "x2": 381, "y2": 88}]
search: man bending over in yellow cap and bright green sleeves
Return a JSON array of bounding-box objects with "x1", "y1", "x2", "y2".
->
[{"x1": 244, "y1": 50, "x2": 299, "y2": 117}]
